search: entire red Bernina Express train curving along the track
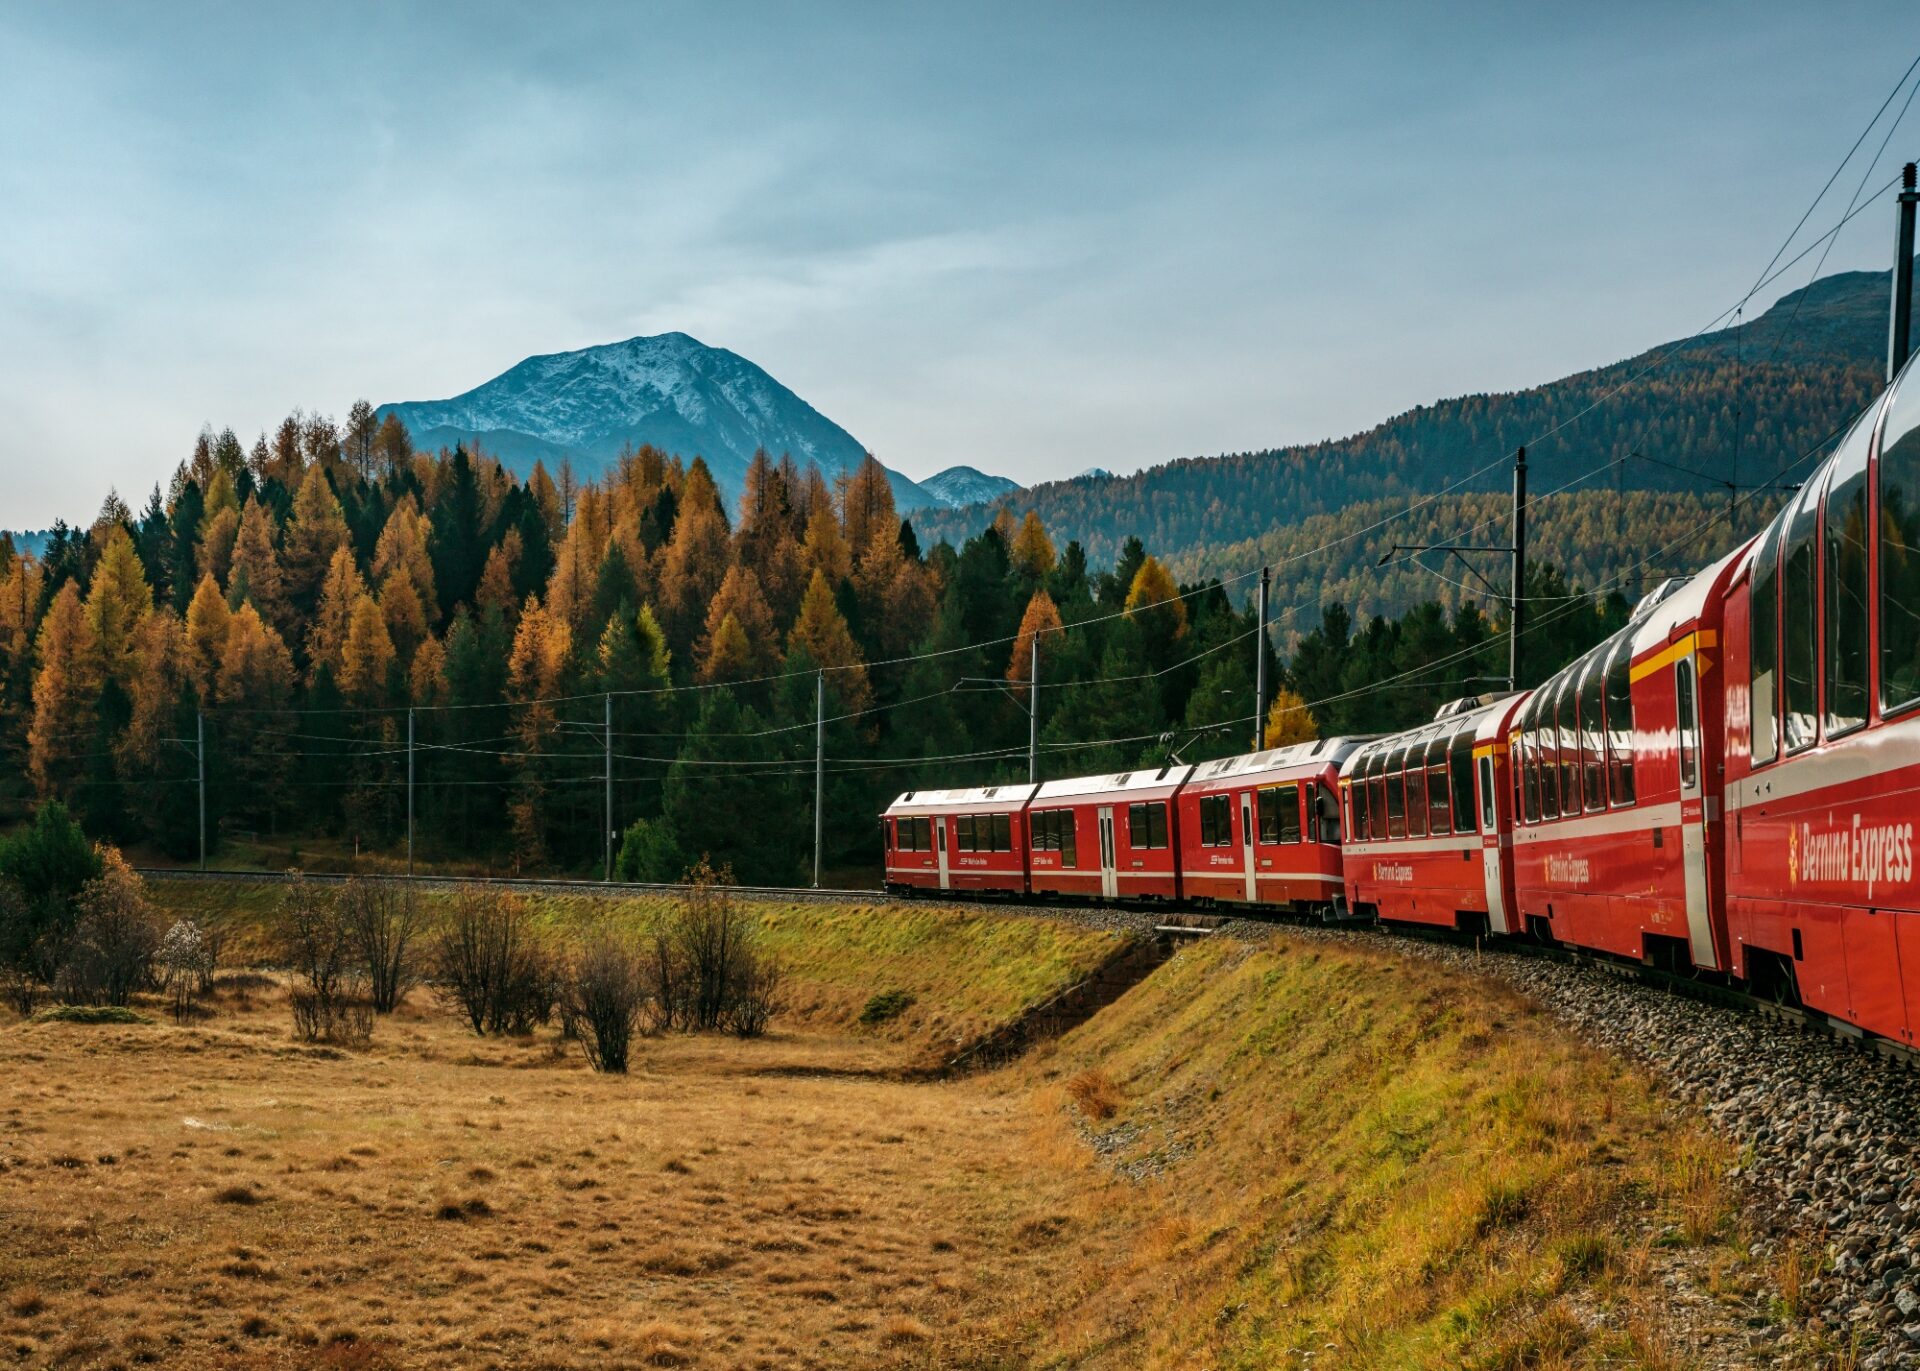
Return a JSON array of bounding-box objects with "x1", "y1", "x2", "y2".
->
[{"x1": 885, "y1": 355, "x2": 1920, "y2": 1045}]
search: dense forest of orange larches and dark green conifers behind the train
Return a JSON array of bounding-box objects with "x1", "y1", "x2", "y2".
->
[{"x1": 0, "y1": 403, "x2": 1628, "y2": 883}]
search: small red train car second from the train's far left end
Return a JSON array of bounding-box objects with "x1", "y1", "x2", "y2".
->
[{"x1": 1027, "y1": 764, "x2": 1192, "y2": 901}]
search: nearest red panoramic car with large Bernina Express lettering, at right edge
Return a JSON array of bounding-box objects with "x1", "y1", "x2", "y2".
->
[{"x1": 1720, "y1": 363, "x2": 1920, "y2": 1045}]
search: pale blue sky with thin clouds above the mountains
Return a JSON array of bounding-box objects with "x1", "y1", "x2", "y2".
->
[{"x1": 0, "y1": 0, "x2": 1920, "y2": 528}]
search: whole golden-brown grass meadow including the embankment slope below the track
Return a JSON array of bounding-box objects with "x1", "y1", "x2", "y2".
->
[{"x1": 0, "y1": 885, "x2": 1820, "y2": 1369}]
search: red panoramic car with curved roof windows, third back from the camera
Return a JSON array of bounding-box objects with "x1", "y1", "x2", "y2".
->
[{"x1": 1340, "y1": 695, "x2": 1526, "y2": 933}]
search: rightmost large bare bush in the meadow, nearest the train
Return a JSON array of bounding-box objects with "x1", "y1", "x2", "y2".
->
[{"x1": 647, "y1": 862, "x2": 783, "y2": 1037}]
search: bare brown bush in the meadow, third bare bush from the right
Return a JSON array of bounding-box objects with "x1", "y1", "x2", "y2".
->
[{"x1": 434, "y1": 885, "x2": 561, "y2": 1035}]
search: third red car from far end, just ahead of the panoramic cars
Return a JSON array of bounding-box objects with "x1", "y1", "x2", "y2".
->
[{"x1": 1175, "y1": 737, "x2": 1359, "y2": 914}]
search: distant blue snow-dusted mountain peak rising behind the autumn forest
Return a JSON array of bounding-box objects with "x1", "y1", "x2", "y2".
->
[{"x1": 378, "y1": 332, "x2": 943, "y2": 509}]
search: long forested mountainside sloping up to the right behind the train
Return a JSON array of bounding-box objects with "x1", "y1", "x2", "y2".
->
[{"x1": 914, "y1": 257, "x2": 1920, "y2": 626}]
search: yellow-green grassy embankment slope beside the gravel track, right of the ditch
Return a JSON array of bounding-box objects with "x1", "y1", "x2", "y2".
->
[{"x1": 1006, "y1": 939, "x2": 1797, "y2": 1369}]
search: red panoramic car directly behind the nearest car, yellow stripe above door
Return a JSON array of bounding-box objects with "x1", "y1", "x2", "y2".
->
[{"x1": 1513, "y1": 549, "x2": 1741, "y2": 970}]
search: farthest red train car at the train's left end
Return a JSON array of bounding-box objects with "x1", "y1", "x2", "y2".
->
[{"x1": 881, "y1": 785, "x2": 1039, "y2": 895}]
